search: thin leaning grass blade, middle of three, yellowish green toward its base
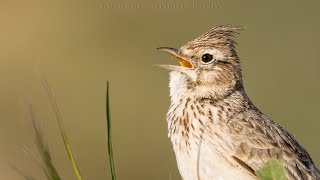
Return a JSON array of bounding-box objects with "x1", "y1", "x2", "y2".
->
[{"x1": 42, "y1": 78, "x2": 82, "y2": 180}]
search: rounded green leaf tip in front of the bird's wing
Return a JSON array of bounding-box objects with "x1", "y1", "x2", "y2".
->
[{"x1": 256, "y1": 159, "x2": 287, "y2": 180}]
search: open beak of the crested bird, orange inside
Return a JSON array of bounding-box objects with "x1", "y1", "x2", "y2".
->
[{"x1": 156, "y1": 47, "x2": 193, "y2": 71}]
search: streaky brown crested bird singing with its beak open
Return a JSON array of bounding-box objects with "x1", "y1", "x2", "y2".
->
[{"x1": 156, "y1": 25, "x2": 320, "y2": 180}]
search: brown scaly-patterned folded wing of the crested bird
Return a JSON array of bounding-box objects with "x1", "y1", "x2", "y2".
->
[{"x1": 227, "y1": 110, "x2": 320, "y2": 180}]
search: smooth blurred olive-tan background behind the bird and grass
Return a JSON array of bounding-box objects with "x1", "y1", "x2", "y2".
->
[{"x1": 0, "y1": 0, "x2": 320, "y2": 180}]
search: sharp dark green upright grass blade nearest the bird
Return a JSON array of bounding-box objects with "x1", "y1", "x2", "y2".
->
[{"x1": 106, "y1": 81, "x2": 117, "y2": 180}]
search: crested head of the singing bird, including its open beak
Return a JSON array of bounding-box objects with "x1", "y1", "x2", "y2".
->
[{"x1": 157, "y1": 25, "x2": 242, "y2": 99}]
